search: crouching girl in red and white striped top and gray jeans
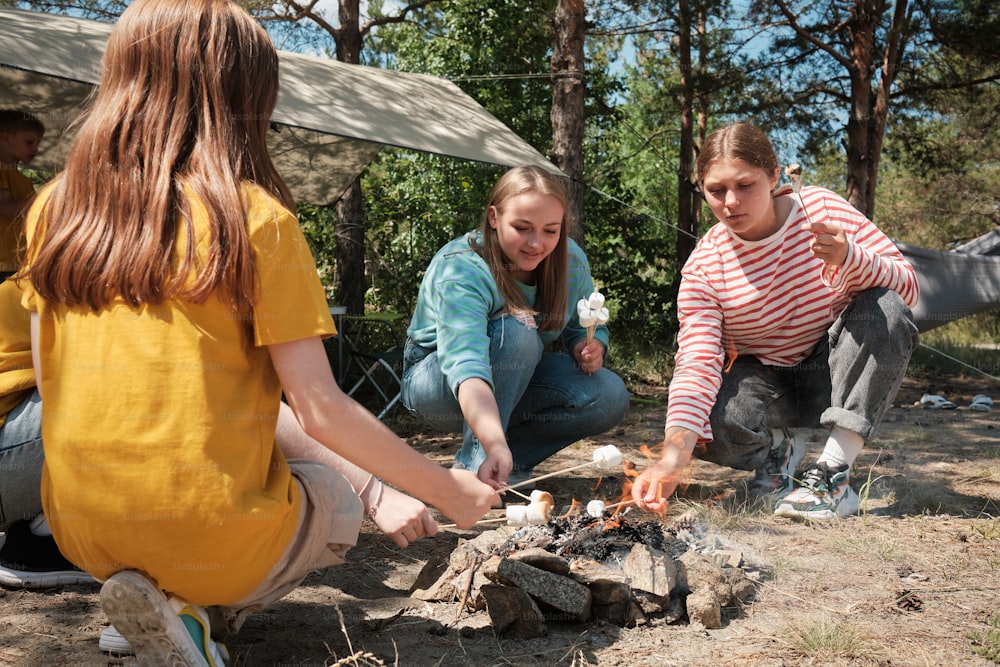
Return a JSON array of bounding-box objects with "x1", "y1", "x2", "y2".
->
[{"x1": 633, "y1": 123, "x2": 918, "y2": 519}]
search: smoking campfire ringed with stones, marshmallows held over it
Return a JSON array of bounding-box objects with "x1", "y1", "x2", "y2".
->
[{"x1": 411, "y1": 448, "x2": 762, "y2": 638}]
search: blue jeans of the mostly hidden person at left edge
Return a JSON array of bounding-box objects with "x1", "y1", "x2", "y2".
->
[{"x1": 0, "y1": 391, "x2": 45, "y2": 532}]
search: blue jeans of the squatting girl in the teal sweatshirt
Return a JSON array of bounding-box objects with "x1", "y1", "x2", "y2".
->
[{"x1": 401, "y1": 315, "x2": 629, "y2": 471}]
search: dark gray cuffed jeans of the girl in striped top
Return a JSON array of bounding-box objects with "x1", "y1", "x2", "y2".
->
[{"x1": 698, "y1": 288, "x2": 920, "y2": 470}]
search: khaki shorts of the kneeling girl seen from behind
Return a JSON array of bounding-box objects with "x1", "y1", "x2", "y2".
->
[{"x1": 210, "y1": 459, "x2": 364, "y2": 633}]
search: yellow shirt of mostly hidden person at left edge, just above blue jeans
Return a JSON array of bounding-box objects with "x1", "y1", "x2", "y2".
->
[{"x1": 0, "y1": 280, "x2": 35, "y2": 427}]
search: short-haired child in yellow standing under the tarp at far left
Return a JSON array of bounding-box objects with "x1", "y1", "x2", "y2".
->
[{"x1": 0, "y1": 109, "x2": 45, "y2": 280}]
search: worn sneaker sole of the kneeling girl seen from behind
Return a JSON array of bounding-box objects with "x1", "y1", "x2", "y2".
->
[{"x1": 101, "y1": 570, "x2": 208, "y2": 667}]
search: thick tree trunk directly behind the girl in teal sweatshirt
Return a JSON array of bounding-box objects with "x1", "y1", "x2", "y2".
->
[{"x1": 550, "y1": 0, "x2": 586, "y2": 246}]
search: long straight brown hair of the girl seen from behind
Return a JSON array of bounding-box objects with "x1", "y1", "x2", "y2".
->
[{"x1": 26, "y1": 0, "x2": 294, "y2": 311}]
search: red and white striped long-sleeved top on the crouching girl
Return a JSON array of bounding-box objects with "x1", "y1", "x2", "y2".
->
[{"x1": 666, "y1": 186, "x2": 919, "y2": 440}]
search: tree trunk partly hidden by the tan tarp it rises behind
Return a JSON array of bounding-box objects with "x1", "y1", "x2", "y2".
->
[{"x1": 334, "y1": 0, "x2": 366, "y2": 315}]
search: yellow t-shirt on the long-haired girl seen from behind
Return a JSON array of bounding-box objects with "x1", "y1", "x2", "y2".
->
[{"x1": 24, "y1": 186, "x2": 335, "y2": 605}]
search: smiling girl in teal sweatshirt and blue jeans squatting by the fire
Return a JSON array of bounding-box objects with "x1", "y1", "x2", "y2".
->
[{"x1": 402, "y1": 167, "x2": 629, "y2": 488}]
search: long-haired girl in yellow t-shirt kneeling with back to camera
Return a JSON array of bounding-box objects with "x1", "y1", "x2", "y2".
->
[{"x1": 21, "y1": 0, "x2": 499, "y2": 664}]
